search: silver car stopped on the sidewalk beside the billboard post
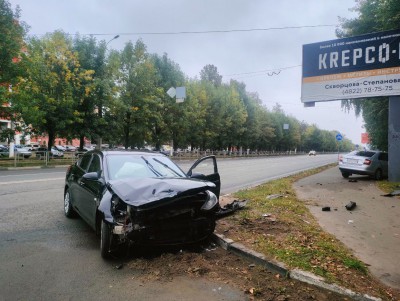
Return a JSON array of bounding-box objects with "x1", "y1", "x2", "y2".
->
[{"x1": 339, "y1": 150, "x2": 388, "y2": 180}]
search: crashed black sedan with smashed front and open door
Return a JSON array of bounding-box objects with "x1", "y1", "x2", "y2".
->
[{"x1": 64, "y1": 150, "x2": 221, "y2": 258}]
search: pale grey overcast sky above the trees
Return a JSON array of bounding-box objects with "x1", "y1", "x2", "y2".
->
[{"x1": 8, "y1": 0, "x2": 363, "y2": 144}]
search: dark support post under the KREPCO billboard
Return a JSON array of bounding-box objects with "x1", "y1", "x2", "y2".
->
[{"x1": 388, "y1": 96, "x2": 400, "y2": 182}]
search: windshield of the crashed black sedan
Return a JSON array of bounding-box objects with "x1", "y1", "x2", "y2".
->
[{"x1": 106, "y1": 154, "x2": 186, "y2": 180}]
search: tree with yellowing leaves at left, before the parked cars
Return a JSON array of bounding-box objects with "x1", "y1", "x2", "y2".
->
[{"x1": 12, "y1": 31, "x2": 93, "y2": 149}]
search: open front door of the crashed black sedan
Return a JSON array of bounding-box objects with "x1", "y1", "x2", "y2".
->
[{"x1": 187, "y1": 156, "x2": 221, "y2": 198}]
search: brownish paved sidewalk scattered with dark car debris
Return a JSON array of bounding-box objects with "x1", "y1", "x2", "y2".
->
[{"x1": 294, "y1": 167, "x2": 400, "y2": 289}]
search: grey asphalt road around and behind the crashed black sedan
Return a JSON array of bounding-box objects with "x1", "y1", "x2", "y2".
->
[{"x1": 0, "y1": 155, "x2": 337, "y2": 301}]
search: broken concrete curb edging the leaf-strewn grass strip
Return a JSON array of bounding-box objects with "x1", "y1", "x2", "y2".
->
[{"x1": 212, "y1": 233, "x2": 382, "y2": 301}]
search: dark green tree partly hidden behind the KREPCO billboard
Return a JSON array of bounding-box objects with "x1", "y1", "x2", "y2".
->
[{"x1": 336, "y1": 0, "x2": 400, "y2": 150}]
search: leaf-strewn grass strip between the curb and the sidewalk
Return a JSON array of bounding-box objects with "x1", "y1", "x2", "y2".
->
[{"x1": 230, "y1": 165, "x2": 368, "y2": 282}]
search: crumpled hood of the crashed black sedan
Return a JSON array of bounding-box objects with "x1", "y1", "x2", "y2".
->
[{"x1": 107, "y1": 178, "x2": 215, "y2": 209}]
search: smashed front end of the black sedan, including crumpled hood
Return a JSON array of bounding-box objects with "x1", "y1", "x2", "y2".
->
[{"x1": 99, "y1": 178, "x2": 220, "y2": 245}]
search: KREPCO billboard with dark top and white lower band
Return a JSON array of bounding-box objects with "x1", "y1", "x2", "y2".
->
[{"x1": 301, "y1": 30, "x2": 400, "y2": 103}]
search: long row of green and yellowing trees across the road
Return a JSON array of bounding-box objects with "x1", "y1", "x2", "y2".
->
[{"x1": 5, "y1": 24, "x2": 353, "y2": 152}]
